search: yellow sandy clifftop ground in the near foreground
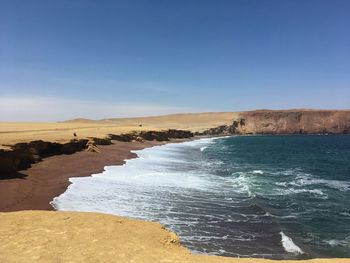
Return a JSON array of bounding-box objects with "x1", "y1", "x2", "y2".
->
[{"x1": 0, "y1": 211, "x2": 350, "y2": 263}]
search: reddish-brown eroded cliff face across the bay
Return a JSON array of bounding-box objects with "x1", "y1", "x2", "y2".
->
[{"x1": 197, "y1": 110, "x2": 350, "y2": 135}]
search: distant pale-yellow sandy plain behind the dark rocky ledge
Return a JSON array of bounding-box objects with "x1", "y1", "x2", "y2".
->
[{"x1": 0, "y1": 113, "x2": 237, "y2": 148}]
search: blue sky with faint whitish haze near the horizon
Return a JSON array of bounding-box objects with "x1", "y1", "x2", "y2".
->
[{"x1": 0, "y1": 0, "x2": 350, "y2": 121}]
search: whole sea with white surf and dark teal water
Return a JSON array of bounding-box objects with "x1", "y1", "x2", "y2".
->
[{"x1": 52, "y1": 135, "x2": 350, "y2": 259}]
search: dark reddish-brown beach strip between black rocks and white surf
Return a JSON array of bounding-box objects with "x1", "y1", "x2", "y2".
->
[{"x1": 0, "y1": 140, "x2": 175, "y2": 212}]
